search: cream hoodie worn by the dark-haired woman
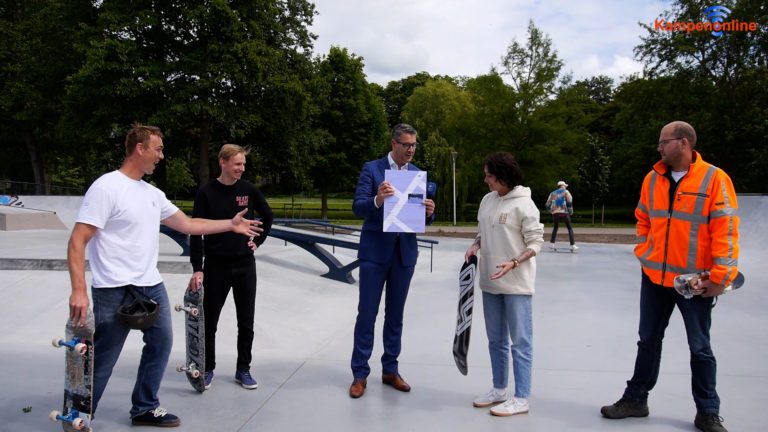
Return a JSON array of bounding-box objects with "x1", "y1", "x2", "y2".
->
[{"x1": 477, "y1": 186, "x2": 544, "y2": 295}]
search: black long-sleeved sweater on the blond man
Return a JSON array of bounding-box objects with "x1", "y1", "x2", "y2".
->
[{"x1": 189, "y1": 179, "x2": 273, "y2": 272}]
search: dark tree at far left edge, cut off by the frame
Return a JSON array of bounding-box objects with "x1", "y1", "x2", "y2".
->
[{"x1": 0, "y1": 0, "x2": 93, "y2": 193}]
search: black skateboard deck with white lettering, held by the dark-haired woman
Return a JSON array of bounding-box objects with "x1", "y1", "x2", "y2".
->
[{"x1": 453, "y1": 255, "x2": 477, "y2": 375}]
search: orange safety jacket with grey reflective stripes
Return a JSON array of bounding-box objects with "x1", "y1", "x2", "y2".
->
[{"x1": 635, "y1": 151, "x2": 739, "y2": 287}]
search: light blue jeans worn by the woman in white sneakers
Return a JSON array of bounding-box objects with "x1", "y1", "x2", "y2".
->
[{"x1": 483, "y1": 291, "x2": 533, "y2": 398}]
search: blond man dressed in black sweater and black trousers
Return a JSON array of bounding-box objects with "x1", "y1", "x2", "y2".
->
[{"x1": 189, "y1": 144, "x2": 273, "y2": 390}]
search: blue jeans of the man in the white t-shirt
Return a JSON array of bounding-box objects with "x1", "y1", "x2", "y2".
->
[{"x1": 91, "y1": 282, "x2": 173, "y2": 417}]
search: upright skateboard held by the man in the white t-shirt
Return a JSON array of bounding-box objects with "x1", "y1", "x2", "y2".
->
[{"x1": 49, "y1": 309, "x2": 96, "y2": 432}]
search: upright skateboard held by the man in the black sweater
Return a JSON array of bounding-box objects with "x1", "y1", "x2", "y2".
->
[{"x1": 175, "y1": 284, "x2": 205, "y2": 393}]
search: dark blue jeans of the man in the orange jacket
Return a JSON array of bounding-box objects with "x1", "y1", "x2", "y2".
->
[{"x1": 624, "y1": 273, "x2": 720, "y2": 414}]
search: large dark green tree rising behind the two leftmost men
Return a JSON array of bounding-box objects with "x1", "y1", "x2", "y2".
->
[{"x1": 69, "y1": 0, "x2": 315, "y2": 189}]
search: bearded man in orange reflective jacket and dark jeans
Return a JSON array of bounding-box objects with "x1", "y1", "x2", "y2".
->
[{"x1": 600, "y1": 121, "x2": 739, "y2": 432}]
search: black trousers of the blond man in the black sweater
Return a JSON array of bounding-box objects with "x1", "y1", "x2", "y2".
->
[{"x1": 203, "y1": 262, "x2": 256, "y2": 371}]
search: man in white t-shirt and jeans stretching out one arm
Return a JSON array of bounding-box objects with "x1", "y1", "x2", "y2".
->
[{"x1": 67, "y1": 125, "x2": 261, "y2": 427}]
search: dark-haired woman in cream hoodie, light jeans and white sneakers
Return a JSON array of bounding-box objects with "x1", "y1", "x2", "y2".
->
[{"x1": 465, "y1": 152, "x2": 544, "y2": 416}]
